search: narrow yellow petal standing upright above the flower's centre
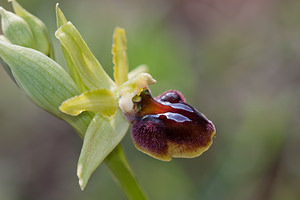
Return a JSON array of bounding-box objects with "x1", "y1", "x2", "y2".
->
[{"x1": 112, "y1": 27, "x2": 128, "y2": 86}]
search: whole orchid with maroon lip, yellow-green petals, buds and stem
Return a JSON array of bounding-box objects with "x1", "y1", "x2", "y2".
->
[{"x1": 0, "y1": 0, "x2": 215, "y2": 199}]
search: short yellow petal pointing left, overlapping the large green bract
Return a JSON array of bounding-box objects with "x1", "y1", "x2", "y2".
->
[{"x1": 59, "y1": 89, "x2": 118, "y2": 116}]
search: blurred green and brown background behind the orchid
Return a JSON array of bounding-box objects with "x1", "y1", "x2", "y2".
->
[{"x1": 0, "y1": 0, "x2": 300, "y2": 200}]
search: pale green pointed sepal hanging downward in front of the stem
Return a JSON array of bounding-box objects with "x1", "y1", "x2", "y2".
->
[{"x1": 77, "y1": 109, "x2": 129, "y2": 190}]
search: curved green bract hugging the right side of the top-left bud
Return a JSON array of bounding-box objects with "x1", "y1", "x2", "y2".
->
[{"x1": 10, "y1": 0, "x2": 52, "y2": 56}]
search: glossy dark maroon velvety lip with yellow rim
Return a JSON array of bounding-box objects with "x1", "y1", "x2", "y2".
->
[{"x1": 132, "y1": 89, "x2": 215, "y2": 161}]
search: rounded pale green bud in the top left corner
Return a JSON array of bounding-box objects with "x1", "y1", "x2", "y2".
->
[{"x1": 0, "y1": 7, "x2": 36, "y2": 48}]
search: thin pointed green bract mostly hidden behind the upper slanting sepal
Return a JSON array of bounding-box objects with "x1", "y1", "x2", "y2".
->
[{"x1": 56, "y1": 3, "x2": 87, "y2": 92}]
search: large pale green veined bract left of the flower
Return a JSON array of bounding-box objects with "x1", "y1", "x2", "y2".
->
[{"x1": 0, "y1": 41, "x2": 92, "y2": 137}]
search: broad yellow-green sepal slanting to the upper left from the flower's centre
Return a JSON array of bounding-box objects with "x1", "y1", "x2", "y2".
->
[{"x1": 55, "y1": 22, "x2": 115, "y2": 90}]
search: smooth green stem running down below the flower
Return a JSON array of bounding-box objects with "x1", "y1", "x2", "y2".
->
[{"x1": 105, "y1": 144, "x2": 147, "y2": 200}]
